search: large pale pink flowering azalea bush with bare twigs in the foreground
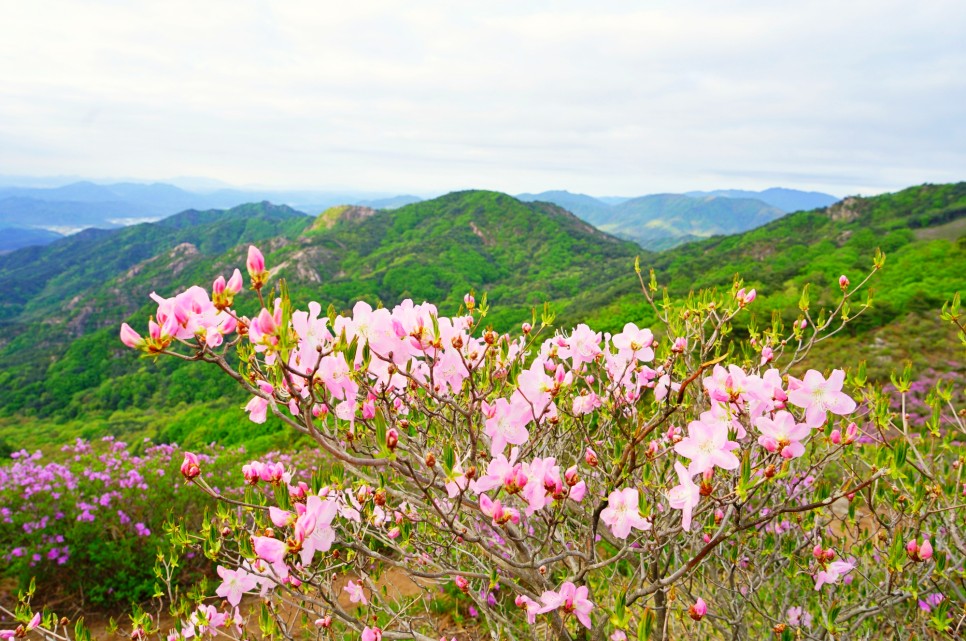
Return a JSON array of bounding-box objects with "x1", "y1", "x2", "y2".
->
[{"x1": 9, "y1": 247, "x2": 966, "y2": 641}]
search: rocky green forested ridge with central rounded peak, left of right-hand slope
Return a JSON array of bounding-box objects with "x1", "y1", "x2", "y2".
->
[{"x1": 0, "y1": 191, "x2": 640, "y2": 424}]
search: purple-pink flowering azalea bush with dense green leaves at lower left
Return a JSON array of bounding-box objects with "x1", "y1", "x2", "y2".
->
[{"x1": 0, "y1": 437, "x2": 234, "y2": 610}]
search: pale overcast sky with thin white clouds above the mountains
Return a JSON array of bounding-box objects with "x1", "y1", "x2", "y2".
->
[{"x1": 0, "y1": 0, "x2": 966, "y2": 196}]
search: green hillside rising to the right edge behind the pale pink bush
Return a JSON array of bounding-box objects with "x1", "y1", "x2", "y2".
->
[{"x1": 589, "y1": 183, "x2": 966, "y2": 375}]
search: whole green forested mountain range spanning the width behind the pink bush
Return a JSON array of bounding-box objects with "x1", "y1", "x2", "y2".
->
[{"x1": 0, "y1": 183, "x2": 966, "y2": 446}]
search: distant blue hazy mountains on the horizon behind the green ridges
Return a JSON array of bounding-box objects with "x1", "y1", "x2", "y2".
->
[{"x1": 0, "y1": 181, "x2": 837, "y2": 251}]
